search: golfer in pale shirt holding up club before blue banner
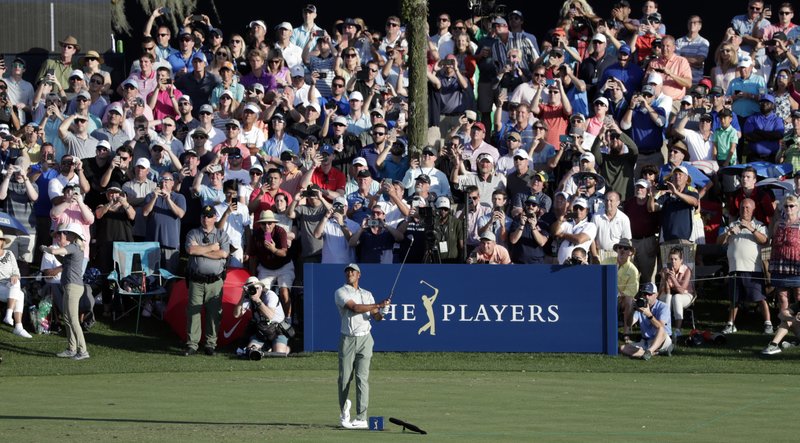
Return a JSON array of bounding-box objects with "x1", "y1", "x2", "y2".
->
[{"x1": 335, "y1": 263, "x2": 390, "y2": 429}]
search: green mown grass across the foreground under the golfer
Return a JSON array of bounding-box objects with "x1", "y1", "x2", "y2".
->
[{"x1": 0, "y1": 300, "x2": 800, "y2": 443}]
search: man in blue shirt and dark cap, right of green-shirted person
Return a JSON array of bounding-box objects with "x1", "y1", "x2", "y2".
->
[{"x1": 742, "y1": 94, "x2": 784, "y2": 163}]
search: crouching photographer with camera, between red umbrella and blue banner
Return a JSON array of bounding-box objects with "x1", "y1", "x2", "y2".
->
[{"x1": 233, "y1": 277, "x2": 289, "y2": 360}]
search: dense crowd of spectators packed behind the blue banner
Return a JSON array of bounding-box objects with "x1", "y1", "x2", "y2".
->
[{"x1": 0, "y1": 0, "x2": 800, "y2": 351}]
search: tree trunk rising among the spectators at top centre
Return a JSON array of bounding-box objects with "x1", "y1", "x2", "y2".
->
[{"x1": 401, "y1": 0, "x2": 428, "y2": 152}]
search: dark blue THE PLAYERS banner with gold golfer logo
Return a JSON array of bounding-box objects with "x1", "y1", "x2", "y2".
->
[{"x1": 304, "y1": 264, "x2": 617, "y2": 355}]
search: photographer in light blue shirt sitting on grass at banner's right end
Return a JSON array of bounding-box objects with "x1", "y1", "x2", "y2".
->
[{"x1": 619, "y1": 282, "x2": 674, "y2": 360}]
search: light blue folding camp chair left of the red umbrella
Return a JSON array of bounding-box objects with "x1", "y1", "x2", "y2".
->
[{"x1": 108, "y1": 242, "x2": 175, "y2": 334}]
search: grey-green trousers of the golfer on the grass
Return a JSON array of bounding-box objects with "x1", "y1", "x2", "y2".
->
[{"x1": 339, "y1": 334, "x2": 374, "y2": 420}]
